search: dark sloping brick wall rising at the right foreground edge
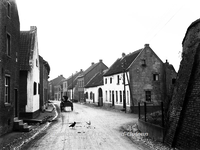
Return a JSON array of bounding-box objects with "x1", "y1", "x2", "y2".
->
[{"x1": 165, "y1": 20, "x2": 200, "y2": 150}]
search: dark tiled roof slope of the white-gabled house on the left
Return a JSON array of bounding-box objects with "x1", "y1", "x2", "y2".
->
[{"x1": 19, "y1": 30, "x2": 36, "y2": 70}]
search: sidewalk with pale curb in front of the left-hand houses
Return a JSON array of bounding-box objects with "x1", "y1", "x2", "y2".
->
[{"x1": 0, "y1": 103, "x2": 58, "y2": 150}]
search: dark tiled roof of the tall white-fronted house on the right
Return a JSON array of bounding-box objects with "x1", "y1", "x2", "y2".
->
[{"x1": 104, "y1": 49, "x2": 142, "y2": 76}]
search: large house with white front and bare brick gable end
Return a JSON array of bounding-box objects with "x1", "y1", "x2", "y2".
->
[{"x1": 103, "y1": 44, "x2": 176, "y2": 112}]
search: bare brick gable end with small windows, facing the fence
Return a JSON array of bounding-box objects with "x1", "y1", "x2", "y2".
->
[{"x1": 127, "y1": 44, "x2": 176, "y2": 109}]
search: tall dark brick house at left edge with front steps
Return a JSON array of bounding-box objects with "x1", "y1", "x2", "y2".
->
[{"x1": 0, "y1": 0, "x2": 20, "y2": 136}]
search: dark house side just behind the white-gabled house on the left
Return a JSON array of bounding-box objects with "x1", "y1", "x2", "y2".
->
[{"x1": 39, "y1": 56, "x2": 50, "y2": 111}]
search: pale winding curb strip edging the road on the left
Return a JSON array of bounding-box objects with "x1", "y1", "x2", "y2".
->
[{"x1": 13, "y1": 103, "x2": 58, "y2": 150}]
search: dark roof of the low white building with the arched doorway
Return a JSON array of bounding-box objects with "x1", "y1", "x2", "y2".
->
[{"x1": 85, "y1": 72, "x2": 104, "y2": 88}]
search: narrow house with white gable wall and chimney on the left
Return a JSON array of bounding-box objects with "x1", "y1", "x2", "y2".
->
[{"x1": 19, "y1": 26, "x2": 40, "y2": 118}]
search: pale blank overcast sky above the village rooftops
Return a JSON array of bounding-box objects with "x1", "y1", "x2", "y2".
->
[{"x1": 16, "y1": 0, "x2": 200, "y2": 80}]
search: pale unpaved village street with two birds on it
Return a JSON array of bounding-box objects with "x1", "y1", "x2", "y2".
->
[{"x1": 23, "y1": 102, "x2": 141, "y2": 150}]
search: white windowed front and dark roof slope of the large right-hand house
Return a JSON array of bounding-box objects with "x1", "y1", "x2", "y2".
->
[{"x1": 103, "y1": 50, "x2": 141, "y2": 111}]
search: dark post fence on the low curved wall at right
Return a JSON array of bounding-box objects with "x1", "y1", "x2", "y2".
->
[{"x1": 138, "y1": 102, "x2": 164, "y2": 127}]
